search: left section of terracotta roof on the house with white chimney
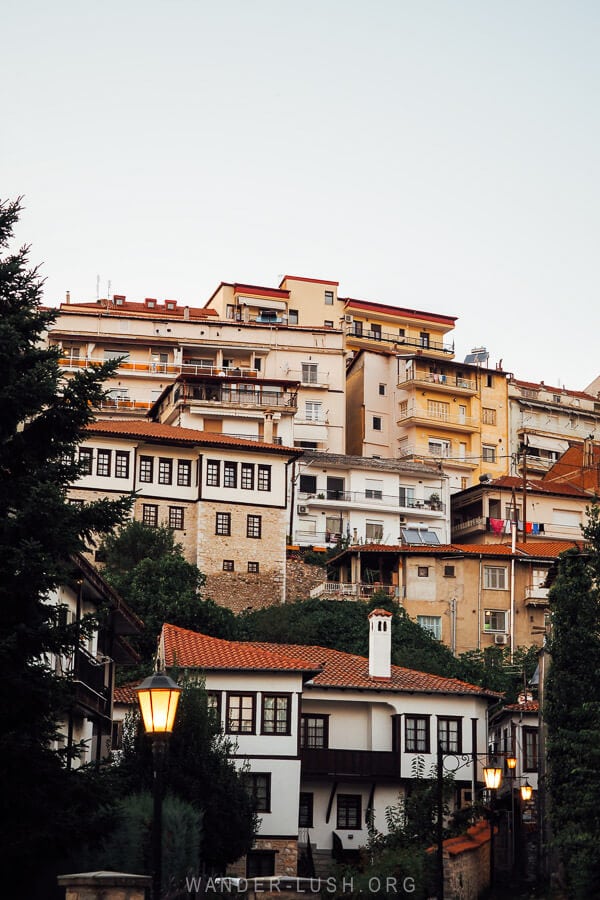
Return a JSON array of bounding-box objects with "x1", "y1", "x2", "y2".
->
[{"x1": 162, "y1": 623, "x2": 319, "y2": 673}]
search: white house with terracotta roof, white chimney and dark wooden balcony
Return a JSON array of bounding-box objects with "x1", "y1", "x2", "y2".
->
[{"x1": 132, "y1": 610, "x2": 499, "y2": 877}]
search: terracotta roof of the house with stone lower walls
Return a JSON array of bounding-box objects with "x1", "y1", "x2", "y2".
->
[{"x1": 86, "y1": 419, "x2": 302, "y2": 456}]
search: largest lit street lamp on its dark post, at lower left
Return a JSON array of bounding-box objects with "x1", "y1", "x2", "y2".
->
[{"x1": 136, "y1": 672, "x2": 181, "y2": 900}]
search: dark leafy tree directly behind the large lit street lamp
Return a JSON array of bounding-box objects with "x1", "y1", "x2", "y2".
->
[{"x1": 118, "y1": 681, "x2": 257, "y2": 871}]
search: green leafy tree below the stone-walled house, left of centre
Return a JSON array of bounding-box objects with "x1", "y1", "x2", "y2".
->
[{"x1": 102, "y1": 522, "x2": 236, "y2": 668}]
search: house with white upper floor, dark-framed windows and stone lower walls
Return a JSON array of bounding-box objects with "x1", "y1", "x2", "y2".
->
[{"x1": 70, "y1": 419, "x2": 299, "y2": 611}]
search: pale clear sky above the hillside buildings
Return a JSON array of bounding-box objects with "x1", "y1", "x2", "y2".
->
[{"x1": 0, "y1": 0, "x2": 600, "y2": 389}]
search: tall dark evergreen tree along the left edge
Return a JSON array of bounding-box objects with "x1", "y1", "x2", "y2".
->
[{"x1": 0, "y1": 200, "x2": 129, "y2": 897}]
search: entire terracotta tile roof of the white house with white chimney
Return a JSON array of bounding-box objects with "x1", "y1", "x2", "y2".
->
[{"x1": 162, "y1": 623, "x2": 501, "y2": 699}]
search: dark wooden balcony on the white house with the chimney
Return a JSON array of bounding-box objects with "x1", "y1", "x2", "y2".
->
[{"x1": 300, "y1": 747, "x2": 400, "y2": 781}]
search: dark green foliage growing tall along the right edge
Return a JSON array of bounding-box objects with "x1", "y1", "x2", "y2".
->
[{"x1": 544, "y1": 506, "x2": 600, "y2": 900}]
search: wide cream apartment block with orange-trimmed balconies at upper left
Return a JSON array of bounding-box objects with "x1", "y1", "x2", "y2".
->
[{"x1": 49, "y1": 285, "x2": 345, "y2": 453}]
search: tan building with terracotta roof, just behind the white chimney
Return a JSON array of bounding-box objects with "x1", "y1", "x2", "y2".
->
[{"x1": 313, "y1": 540, "x2": 577, "y2": 654}]
